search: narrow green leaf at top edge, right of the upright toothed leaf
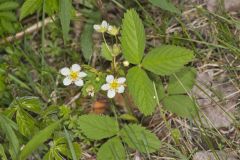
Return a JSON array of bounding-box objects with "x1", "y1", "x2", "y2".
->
[{"x1": 149, "y1": 0, "x2": 181, "y2": 14}]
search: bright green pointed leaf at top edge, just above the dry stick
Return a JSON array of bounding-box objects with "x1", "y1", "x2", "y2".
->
[{"x1": 20, "y1": 0, "x2": 43, "y2": 20}]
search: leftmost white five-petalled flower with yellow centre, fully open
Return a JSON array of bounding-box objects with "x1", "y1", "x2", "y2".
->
[{"x1": 60, "y1": 64, "x2": 87, "y2": 86}]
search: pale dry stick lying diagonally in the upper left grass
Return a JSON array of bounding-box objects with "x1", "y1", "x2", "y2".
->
[{"x1": 0, "y1": 17, "x2": 55, "y2": 45}]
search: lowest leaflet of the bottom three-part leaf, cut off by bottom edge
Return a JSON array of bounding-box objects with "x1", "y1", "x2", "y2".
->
[{"x1": 97, "y1": 137, "x2": 126, "y2": 160}]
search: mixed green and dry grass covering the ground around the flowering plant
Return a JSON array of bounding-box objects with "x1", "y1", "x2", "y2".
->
[{"x1": 0, "y1": 0, "x2": 240, "y2": 160}]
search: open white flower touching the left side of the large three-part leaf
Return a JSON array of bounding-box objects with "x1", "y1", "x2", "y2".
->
[{"x1": 101, "y1": 75, "x2": 126, "y2": 98}]
